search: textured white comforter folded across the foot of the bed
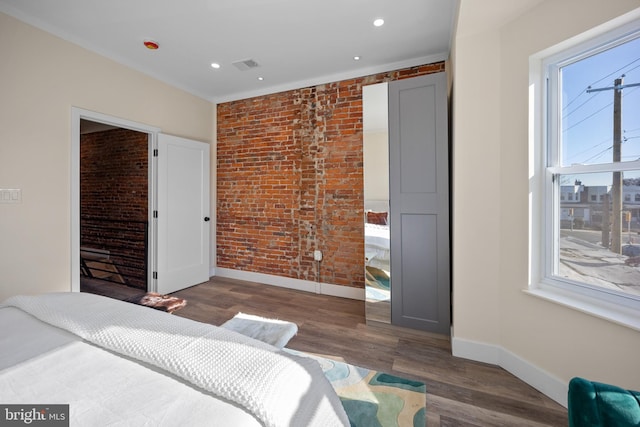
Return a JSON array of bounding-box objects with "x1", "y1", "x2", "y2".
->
[{"x1": 2, "y1": 293, "x2": 349, "y2": 427}]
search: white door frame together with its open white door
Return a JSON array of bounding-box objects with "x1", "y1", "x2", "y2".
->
[{"x1": 70, "y1": 107, "x2": 211, "y2": 298}]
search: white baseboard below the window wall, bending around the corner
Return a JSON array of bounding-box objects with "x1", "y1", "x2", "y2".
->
[{"x1": 451, "y1": 338, "x2": 569, "y2": 408}]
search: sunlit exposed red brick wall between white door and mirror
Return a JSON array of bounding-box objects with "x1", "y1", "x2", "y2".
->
[{"x1": 217, "y1": 62, "x2": 445, "y2": 288}]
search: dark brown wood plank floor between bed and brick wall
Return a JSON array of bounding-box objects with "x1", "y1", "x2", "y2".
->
[{"x1": 82, "y1": 277, "x2": 568, "y2": 427}]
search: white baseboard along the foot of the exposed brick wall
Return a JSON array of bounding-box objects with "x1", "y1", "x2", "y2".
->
[{"x1": 210, "y1": 267, "x2": 365, "y2": 301}]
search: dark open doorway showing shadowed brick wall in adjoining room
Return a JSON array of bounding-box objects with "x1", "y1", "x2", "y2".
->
[{"x1": 80, "y1": 119, "x2": 150, "y2": 299}]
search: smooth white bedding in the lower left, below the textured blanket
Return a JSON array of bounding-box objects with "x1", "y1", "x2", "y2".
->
[{"x1": 0, "y1": 307, "x2": 262, "y2": 427}]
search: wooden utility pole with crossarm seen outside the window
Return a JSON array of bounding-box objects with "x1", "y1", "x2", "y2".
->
[{"x1": 587, "y1": 74, "x2": 640, "y2": 254}]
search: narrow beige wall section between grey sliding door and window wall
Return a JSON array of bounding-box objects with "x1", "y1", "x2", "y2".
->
[{"x1": 452, "y1": 27, "x2": 501, "y2": 342}]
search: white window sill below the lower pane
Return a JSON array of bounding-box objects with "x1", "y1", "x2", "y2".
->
[{"x1": 524, "y1": 284, "x2": 640, "y2": 332}]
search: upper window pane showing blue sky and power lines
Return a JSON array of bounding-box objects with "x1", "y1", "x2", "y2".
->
[{"x1": 559, "y1": 38, "x2": 640, "y2": 166}]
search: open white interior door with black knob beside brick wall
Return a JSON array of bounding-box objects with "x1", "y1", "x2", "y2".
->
[{"x1": 156, "y1": 134, "x2": 211, "y2": 294}]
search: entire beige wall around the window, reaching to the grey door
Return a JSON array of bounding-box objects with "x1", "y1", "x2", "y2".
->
[{"x1": 452, "y1": 0, "x2": 640, "y2": 398}]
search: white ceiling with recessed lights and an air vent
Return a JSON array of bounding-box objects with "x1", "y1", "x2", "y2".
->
[{"x1": 0, "y1": 0, "x2": 458, "y2": 102}]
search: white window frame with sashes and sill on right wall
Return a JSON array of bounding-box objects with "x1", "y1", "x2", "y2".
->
[{"x1": 525, "y1": 15, "x2": 640, "y2": 331}]
